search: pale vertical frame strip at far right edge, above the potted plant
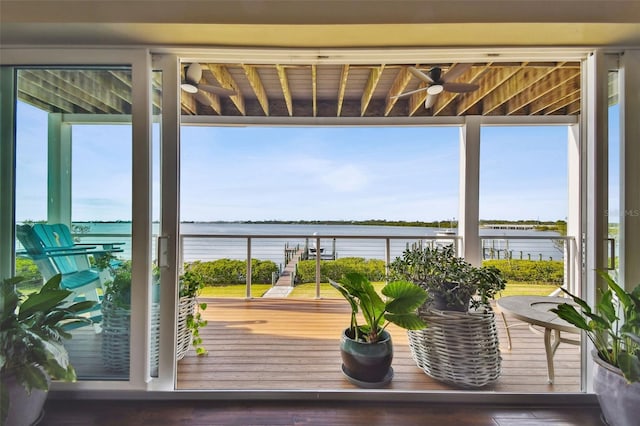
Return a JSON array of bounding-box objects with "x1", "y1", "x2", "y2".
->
[{"x1": 619, "y1": 50, "x2": 640, "y2": 290}]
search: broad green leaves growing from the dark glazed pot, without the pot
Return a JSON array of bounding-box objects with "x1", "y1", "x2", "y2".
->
[{"x1": 329, "y1": 272, "x2": 427, "y2": 343}]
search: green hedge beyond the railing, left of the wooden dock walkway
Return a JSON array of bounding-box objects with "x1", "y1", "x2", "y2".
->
[{"x1": 184, "y1": 259, "x2": 278, "y2": 286}]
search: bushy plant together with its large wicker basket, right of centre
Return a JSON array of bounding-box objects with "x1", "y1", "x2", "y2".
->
[{"x1": 389, "y1": 246, "x2": 505, "y2": 388}]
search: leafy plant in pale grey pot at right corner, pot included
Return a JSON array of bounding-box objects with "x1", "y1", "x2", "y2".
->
[{"x1": 551, "y1": 271, "x2": 640, "y2": 426}]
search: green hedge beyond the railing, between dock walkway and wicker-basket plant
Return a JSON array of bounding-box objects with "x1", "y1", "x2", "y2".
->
[{"x1": 296, "y1": 257, "x2": 385, "y2": 283}]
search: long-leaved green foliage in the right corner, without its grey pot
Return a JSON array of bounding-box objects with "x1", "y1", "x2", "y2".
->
[{"x1": 551, "y1": 271, "x2": 640, "y2": 383}]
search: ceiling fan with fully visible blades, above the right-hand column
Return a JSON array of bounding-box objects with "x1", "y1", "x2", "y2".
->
[{"x1": 393, "y1": 64, "x2": 480, "y2": 108}]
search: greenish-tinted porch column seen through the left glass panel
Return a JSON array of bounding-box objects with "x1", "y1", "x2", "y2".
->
[{"x1": 47, "y1": 113, "x2": 71, "y2": 226}]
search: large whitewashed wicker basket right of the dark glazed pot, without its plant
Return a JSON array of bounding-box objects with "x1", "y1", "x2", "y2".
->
[{"x1": 407, "y1": 310, "x2": 502, "y2": 388}]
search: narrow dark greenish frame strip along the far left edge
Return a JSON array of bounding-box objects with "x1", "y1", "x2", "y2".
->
[{"x1": 0, "y1": 67, "x2": 16, "y2": 280}]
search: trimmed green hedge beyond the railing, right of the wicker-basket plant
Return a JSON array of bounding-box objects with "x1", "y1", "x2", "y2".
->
[{"x1": 482, "y1": 259, "x2": 564, "y2": 283}]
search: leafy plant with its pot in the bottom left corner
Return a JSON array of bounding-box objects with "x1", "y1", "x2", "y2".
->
[{"x1": 0, "y1": 275, "x2": 96, "y2": 425}]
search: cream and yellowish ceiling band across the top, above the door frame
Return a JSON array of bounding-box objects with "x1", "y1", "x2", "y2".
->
[{"x1": 0, "y1": 0, "x2": 640, "y2": 48}]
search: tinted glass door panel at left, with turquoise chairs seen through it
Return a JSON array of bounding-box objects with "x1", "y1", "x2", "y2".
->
[{"x1": 15, "y1": 67, "x2": 132, "y2": 380}]
